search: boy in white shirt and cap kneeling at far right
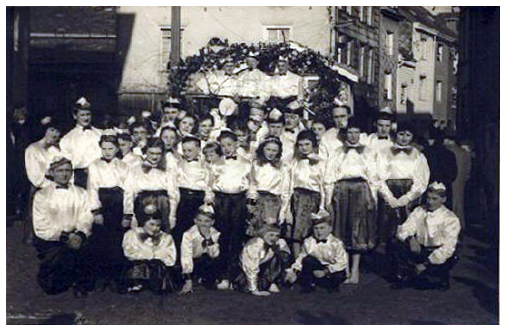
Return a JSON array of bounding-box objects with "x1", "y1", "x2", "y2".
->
[{"x1": 392, "y1": 182, "x2": 460, "y2": 291}]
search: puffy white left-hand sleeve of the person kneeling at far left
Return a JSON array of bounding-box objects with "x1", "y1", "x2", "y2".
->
[{"x1": 32, "y1": 191, "x2": 61, "y2": 241}]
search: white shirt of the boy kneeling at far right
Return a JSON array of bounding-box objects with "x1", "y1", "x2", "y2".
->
[{"x1": 397, "y1": 206, "x2": 460, "y2": 264}]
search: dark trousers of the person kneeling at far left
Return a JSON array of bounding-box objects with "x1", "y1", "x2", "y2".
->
[{"x1": 34, "y1": 237, "x2": 95, "y2": 294}]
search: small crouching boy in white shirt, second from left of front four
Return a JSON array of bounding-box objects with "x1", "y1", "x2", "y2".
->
[{"x1": 181, "y1": 204, "x2": 220, "y2": 294}]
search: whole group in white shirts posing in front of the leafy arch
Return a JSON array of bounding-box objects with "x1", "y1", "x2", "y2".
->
[{"x1": 14, "y1": 92, "x2": 461, "y2": 297}]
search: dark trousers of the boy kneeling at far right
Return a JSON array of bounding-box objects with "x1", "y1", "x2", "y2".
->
[{"x1": 393, "y1": 240, "x2": 458, "y2": 284}]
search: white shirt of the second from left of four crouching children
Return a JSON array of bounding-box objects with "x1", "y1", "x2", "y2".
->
[{"x1": 181, "y1": 225, "x2": 220, "y2": 274}]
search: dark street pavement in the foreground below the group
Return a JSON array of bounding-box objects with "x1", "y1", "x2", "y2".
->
[{"x1": 6, "y1": 222, "x2": 499, "y2": 324}]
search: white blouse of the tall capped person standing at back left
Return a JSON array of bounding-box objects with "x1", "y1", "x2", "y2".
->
[{"x1": 60, "y1": 124, "x2": 102, "y2": 169}]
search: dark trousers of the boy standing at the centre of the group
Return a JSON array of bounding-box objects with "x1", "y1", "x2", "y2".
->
[{"x1": 214, "y1": 192, "x2": 247, "y2": 279}]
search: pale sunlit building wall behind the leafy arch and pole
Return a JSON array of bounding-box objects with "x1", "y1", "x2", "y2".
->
[{"x1": 117, "y1": 6, "x2": 331, "y2": 112}]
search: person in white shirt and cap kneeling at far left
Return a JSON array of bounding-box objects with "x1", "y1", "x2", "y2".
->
[{"x1": 33, "y1": 157, "x2": 95, "y2": 298}]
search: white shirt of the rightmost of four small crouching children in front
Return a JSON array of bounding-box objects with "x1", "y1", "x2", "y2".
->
[{"x1": 291, "y1": 234, "x2": 348, "y2": 273}]
